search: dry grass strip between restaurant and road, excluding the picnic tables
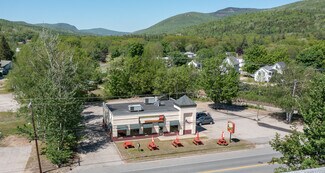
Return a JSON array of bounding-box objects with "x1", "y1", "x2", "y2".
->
[{"x1": 116, "y1": 138, "x2": 254, "y2": 162}]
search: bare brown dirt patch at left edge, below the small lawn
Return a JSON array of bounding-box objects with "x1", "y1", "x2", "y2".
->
[{"x1": 0, "y1": 135, "x2": 31, "y2": 147}]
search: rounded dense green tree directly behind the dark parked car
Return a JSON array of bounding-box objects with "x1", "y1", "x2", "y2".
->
[{"x1": 201, "y1": 58, "x2": 239, "y2": 105}]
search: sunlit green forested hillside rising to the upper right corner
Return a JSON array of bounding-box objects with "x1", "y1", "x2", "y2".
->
[{"x1": 183, "y1": 0, "x2": 325, "y2": 38}]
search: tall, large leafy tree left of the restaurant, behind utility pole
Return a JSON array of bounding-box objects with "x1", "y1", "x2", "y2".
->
[{"x1": 9, "y1": 32, "x2": 94, "y2": 165}]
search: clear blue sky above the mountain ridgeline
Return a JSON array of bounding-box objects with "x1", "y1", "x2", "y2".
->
[{"x1": 0, "y1": 0, "x2": 298, "y2": 32}]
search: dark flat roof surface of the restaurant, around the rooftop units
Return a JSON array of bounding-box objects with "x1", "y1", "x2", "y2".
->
[{"x1": 106, "y1": 100, "x2": 178, "y2": 116}]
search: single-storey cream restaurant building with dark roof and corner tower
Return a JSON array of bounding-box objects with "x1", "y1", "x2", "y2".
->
[{"x1": 103, "y1": 95, "x2": 196, "y2": 140}]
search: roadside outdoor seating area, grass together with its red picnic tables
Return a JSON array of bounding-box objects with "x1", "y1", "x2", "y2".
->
[{"x1": 115, "y1": 135, "x2": 254, "y2": 162}]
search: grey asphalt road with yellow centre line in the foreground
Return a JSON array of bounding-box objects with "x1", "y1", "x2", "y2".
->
[{"x1": 76, "y1": 147, "x2": 280, "y2": 173}]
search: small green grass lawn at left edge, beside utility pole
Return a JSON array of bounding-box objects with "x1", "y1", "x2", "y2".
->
[{"x1": 0, "y1": 112, "x2": 25, "y2": 136}]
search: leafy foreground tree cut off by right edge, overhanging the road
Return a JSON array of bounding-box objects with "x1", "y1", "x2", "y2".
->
[{"x1": 270, "y1": 74, "x2": 325, "y2": 172}]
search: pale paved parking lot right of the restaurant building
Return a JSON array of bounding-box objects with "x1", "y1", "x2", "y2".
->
[{"x1": 197, "y1": 102, "x2": 302, "y2": 144}]
